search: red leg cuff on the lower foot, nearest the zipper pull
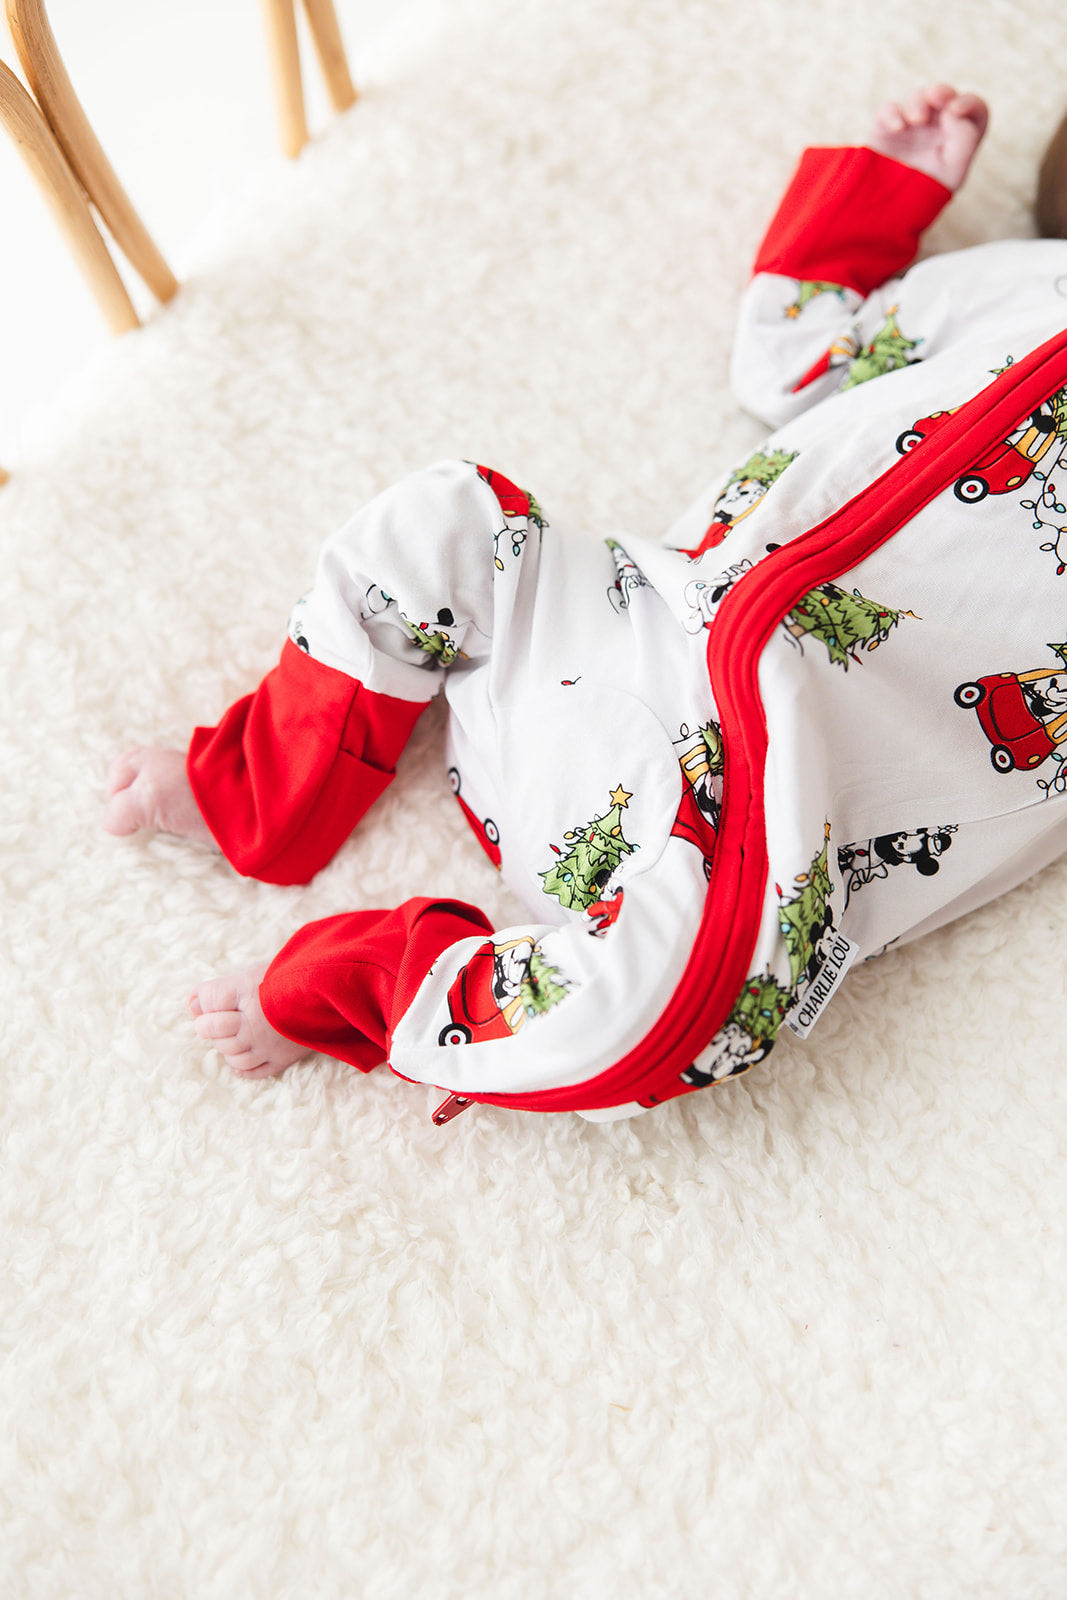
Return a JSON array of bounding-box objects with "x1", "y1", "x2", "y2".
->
[{"x1": 259, "y1": 899, "x2": 493, "y2": 1072}]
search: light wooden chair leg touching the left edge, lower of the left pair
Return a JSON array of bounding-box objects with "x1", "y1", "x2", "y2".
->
[{"x1": 0, "y1": 61, "x2": 139, "y2": 333}]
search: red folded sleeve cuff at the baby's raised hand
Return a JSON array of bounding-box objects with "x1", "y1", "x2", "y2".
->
[{"x1": 753, "y1": 147, "x2": 952, "y2": 296}]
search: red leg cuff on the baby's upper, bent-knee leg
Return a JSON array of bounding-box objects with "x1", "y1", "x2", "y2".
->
[{"x1": 186, "y1": 640, "x2": 429, "y2": 883}]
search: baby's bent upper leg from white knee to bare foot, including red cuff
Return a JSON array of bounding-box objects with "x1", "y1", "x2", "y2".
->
[{"x1": 104, "y1": 462, "x2": 518, "y2": 883}]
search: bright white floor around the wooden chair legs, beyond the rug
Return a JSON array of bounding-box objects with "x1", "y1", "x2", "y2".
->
[{"x1": 0, "y1": 0, "x2": 410, "y2": 462}]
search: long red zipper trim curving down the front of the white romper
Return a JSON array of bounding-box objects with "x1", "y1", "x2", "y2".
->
[{"x1": 434, "y1": 331, "x2": 1067, "y2": 1122}]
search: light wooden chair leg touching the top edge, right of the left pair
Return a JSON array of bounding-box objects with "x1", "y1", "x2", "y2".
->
[{"x1": 5, "y1": 0, "x2": 178, "y2": 301}]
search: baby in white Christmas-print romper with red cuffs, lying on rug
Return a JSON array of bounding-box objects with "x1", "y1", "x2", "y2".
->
[{"x1": 106, "y1": 85, "x2": 1067, "y2": 1122}]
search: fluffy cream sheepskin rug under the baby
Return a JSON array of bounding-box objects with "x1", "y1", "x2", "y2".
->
[{"x1": 0, "y1": 0, "x2": 1067, "y2": 1600}]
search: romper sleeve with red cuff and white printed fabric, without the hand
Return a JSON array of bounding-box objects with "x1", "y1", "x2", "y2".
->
[{"x1": 731, "y1": 147, "x2": 952, "y2": 427}]
